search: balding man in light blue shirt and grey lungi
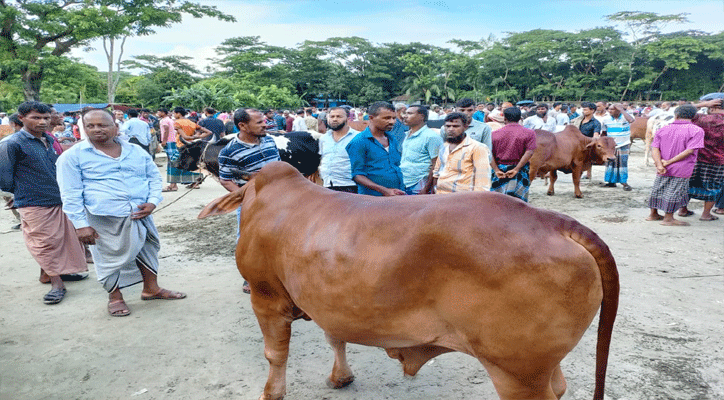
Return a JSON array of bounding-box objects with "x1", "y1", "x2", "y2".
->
[{"x1": 57, "y1": 110, "x2": 186, "y2": 317}]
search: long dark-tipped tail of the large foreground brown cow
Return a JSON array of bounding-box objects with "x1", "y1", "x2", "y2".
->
[{"x1": 565, "y1": 219, "x2": 619, "y2": 400}]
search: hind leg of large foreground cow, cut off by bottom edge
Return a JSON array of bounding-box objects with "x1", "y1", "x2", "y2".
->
[{"x1": 483, "y1": 362, "x2": 558, "y2": 400}]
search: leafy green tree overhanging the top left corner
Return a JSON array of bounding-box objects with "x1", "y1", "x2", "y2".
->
[{"x1": 0, "y1": 0, "x2": 234, "y2": 100}]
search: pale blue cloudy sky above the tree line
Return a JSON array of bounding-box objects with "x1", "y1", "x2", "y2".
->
[{"x1": 72, "y1": 0, "x2": 724, "y2": 71}]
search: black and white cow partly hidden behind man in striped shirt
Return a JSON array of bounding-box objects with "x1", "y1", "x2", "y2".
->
[{"x1": 174, "y1": 131, "x2": 321, "y2": 178}]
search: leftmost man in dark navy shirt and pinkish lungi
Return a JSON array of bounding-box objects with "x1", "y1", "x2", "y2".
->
[{"x1": 0, "y1": 101, "x2": 88, "y2": 304}]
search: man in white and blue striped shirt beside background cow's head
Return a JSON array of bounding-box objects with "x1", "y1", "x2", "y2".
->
[{"x1": 601, "y1": 104, "x2": 634, "y2": 191}]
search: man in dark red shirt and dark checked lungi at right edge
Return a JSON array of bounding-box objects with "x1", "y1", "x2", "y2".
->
[{"x1": 679, "y1": 99, "x2": 724, "y2": 221}]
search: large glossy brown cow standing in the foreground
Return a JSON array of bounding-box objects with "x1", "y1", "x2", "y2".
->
[{"x1": 199, "y1": 162, "x2": 619, "y2": 400}]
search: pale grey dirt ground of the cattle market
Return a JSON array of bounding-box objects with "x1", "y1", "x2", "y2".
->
[{"x1": 0, "y1": 143, "x2": 724, "y2": 400}]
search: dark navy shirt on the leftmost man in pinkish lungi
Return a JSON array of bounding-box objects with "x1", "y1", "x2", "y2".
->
[{"x1": 0, "y1": 129, "x2": 62, "y2": 208}]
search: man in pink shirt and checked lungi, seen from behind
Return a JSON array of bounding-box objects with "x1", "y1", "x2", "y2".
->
[{"x1": 646, "y1": 104, "x2": 704, "y2": 226}]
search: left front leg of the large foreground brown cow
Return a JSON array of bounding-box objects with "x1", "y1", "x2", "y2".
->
[{"x1": 252, "y1": 292, "x2": 292, "y2": 400}]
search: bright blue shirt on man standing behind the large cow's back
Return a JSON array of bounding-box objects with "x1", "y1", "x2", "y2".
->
[{"x1": 346, "y1": 127, "x2": 405, "y2": 196}]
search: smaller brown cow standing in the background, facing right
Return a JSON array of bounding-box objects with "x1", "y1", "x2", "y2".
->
[{"x1": 530, "y1": 125, "x2": 616, "y2": 199}]
